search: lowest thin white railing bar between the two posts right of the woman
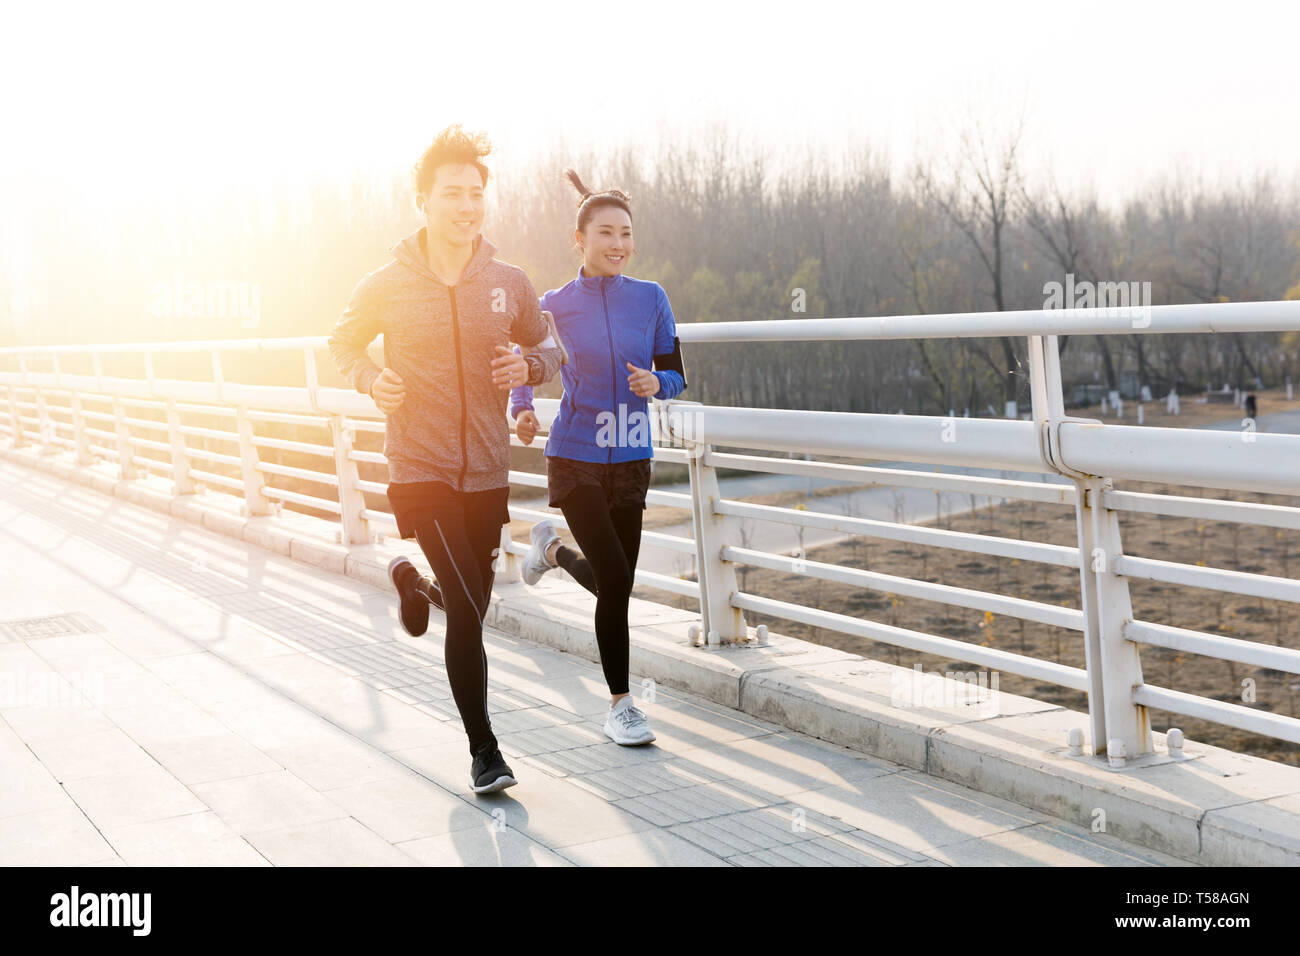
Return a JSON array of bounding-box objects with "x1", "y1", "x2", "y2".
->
[{"x1": 731, "y1": 592, "x2": 1088, "y2": 691}]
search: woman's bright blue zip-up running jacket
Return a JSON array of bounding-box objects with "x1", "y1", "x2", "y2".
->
[{"x1": 510, "y1": 268, "x2": 686, "y2": 463}]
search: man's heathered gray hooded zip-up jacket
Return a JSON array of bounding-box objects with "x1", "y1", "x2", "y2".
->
[{"x1": 329, "y1": 229, "x2": 560, "y2": 492}]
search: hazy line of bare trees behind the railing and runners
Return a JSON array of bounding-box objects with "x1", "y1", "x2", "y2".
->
[{"x1": 0, "y1": 125, "x2": 1300, "y2": 415}]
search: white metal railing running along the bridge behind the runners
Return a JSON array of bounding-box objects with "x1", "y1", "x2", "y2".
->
[{"x1": 0, "y1": 295, "x2": 1300, "y2": 762}]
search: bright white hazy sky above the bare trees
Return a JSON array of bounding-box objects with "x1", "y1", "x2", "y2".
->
[{"x1": 0, "y1": 0, "x2": 1300, "y2": 210}]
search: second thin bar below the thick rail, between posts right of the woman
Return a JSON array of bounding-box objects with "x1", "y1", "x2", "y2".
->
[{"x1": 714, "y1": 498, "x2": 1079, "y2": 568}]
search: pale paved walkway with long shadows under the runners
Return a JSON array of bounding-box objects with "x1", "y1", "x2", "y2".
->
[{"x1": 0, "y1": 463, "x2": 1179, "y2": 866}]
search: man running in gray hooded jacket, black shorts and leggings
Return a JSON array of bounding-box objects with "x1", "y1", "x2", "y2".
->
[{"x1": 329, "y1": 126, "x2": 560, "y2": 793}]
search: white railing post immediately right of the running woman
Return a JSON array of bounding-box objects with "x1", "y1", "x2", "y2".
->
[{"x1": 660, "y1": 402, "x2": 749, "y2": 645}]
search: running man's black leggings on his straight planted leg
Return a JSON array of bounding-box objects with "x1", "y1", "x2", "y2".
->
[{"x1": 415, "y1": 510, "x2": 501, "y2": 753}]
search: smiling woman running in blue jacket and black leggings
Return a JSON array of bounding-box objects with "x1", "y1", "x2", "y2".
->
[{"x1": 511, "y1": 169, "x2": 686, "y2": 745}]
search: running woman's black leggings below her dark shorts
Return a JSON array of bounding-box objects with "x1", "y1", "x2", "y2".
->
[{"x1": 555, "y1": 485, "x2": 642, "y2": 695}]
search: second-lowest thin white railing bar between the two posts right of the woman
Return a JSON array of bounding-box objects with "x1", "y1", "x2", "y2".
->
[{"x1": 722, "y1": 545, "x2": 1083, "y2": 631}]
